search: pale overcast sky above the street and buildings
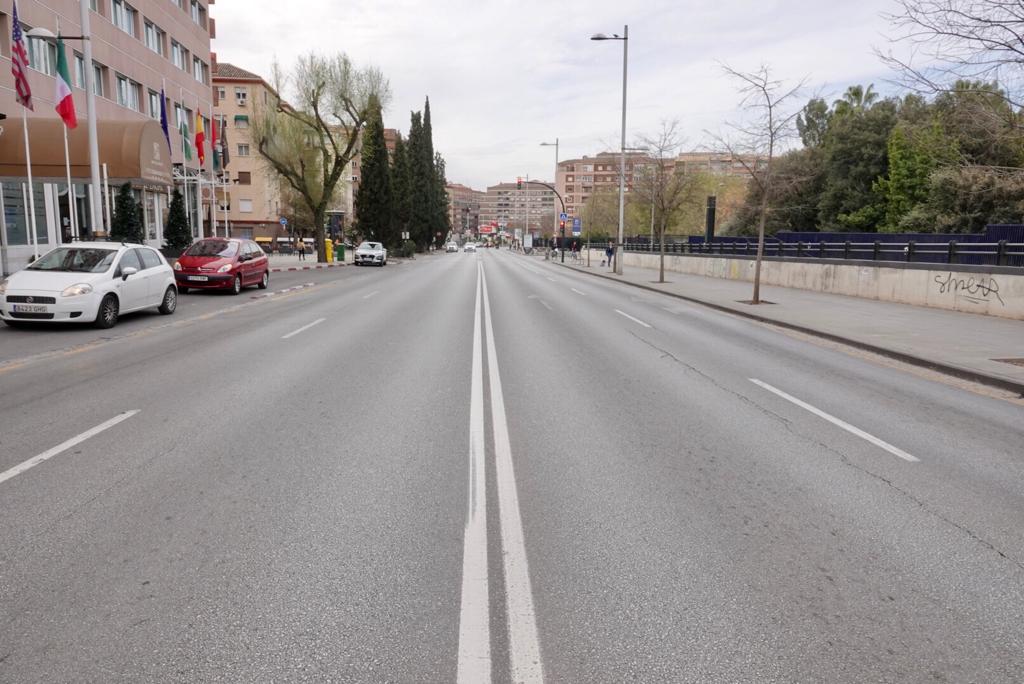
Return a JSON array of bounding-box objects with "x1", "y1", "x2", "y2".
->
[{"x1": 211, "y1": 0, "x2": 909, "y2": 189}]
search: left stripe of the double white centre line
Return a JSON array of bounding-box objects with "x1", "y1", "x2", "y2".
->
[{"x1": 457, "y1": 263, "x2": 490, "y2": 684}]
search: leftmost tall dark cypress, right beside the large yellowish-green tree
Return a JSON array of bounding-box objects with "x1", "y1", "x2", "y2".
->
[{"x1": 355, "y1": 98, "x2": 399, "y2": 247}]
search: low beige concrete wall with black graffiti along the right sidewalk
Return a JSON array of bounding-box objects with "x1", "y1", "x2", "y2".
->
[{"x1": 591, "y1": 250, "x2": 1024, "y2": 320}]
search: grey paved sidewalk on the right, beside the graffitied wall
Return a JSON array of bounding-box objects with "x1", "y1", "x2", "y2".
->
[{"x1": 564, "y1": 260, "x2": 1024, "y2": 395}]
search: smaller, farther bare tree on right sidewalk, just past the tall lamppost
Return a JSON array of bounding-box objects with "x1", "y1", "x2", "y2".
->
[{"x1": 634, "y1": 121, "x2": 698, "y2": 283}]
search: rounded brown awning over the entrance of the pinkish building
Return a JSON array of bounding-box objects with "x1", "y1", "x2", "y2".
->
[{"x1": 0, "y1": 119, "x2": 171, "y2": 185}]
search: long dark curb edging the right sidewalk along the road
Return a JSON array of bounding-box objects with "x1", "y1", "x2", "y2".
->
[{"x1": 559, "y1": 264, "x2": 1024, "y2": 397}]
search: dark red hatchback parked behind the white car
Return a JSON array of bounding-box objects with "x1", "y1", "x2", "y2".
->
[{"x1": 174, "y1": 238, "x2": 270, "y2": 295}]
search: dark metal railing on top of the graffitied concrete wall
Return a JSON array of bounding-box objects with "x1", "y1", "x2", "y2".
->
[{"x1": 610, "y1": 239, "x2": 1024, "y2": 267}]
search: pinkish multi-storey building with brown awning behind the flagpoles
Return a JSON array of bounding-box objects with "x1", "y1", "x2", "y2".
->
[{"x1": 0, "y1": 0, "x2": 216, "y2": 270}]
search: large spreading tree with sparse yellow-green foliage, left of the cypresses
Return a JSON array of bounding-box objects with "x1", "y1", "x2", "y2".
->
[{"x1": 252, "y1": 54, "x2": 390, "y2": 261}]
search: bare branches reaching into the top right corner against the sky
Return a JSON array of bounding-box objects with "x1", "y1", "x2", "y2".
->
[{"x1": 877, "y1": 0, "x2": 1024, "y2": 108}]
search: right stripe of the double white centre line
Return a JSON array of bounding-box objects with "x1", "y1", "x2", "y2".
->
[{"x1": 481, "y1": 264, "x2": 544, "y2": 683}]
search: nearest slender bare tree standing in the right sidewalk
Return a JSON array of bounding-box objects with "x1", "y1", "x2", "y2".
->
[{"x1": 712, "y1": 65, "x2": 805, "y2": 304}]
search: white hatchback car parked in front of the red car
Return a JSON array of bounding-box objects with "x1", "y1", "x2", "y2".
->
[{"x1": 0, "y1": 242, "x2": 178, "y2": 328}]
